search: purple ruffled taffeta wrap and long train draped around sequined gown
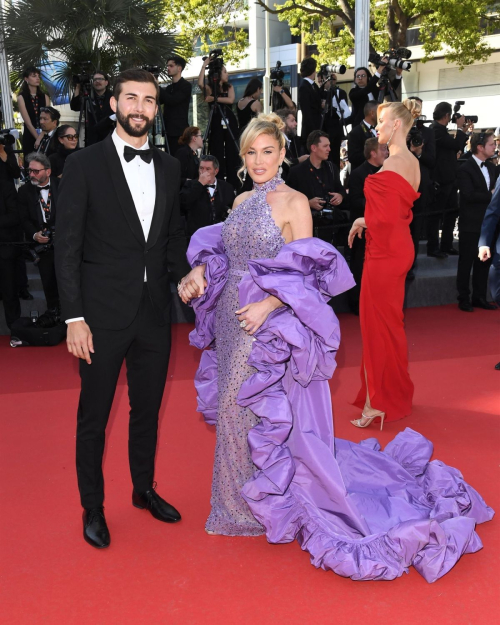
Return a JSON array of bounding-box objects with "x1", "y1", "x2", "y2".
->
[{"x1": 189, "y1": 226, "x2": 493, "y2": 582}]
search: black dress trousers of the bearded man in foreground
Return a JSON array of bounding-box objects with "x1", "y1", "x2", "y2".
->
[{"x1": 76, "y1": 283, "x2": 171, "y2": 508}]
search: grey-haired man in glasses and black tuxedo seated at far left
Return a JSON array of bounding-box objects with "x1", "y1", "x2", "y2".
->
[{"x1": 17, "y1": 152, "x2": 60, "y2": 315}]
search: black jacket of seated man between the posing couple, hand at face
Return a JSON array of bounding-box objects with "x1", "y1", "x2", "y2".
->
[{"x1": 181, "y1": 176, "x2": 234, "y2": 236}]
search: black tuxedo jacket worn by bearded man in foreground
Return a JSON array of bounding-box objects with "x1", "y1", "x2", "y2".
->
[{"x1": 55, "y1": 136, "x2": 189, "y2": 330}]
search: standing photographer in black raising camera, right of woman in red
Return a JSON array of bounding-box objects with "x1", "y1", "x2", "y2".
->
[{"x1": 427, "y1": 102, "x2": 468, "y2": 258}]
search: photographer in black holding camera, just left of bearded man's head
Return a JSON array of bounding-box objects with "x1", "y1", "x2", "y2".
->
[{"x1": 70, "y1": 71, "x2": 113, "y2": 146}]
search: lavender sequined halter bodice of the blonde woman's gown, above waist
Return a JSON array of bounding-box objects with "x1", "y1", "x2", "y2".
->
[{"x1": 222, "y1": 176, "x2": 285, "y2": 271}]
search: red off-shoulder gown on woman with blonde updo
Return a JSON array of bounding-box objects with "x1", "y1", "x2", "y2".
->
[{"x1": 354, "y1": 171, "x2": 419, "y2": 421}]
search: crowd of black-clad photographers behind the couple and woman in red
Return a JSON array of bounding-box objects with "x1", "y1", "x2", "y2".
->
[{"x1": 0, "y1": 51, "x2": 500, "y2": 327}]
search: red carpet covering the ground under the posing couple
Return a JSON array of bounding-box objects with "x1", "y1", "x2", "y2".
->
[{"x1": 0, "y1": 306, "x2": 500, "y2": 625}]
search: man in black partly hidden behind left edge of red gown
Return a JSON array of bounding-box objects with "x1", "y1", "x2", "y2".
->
[{"x1": 347, "y1": 137, "x2": 389, "y2": 315}]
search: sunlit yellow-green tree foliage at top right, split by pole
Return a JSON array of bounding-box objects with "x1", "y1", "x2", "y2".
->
[{"x1": 256, "y1": 0, "x2": 498, "y2": 67}]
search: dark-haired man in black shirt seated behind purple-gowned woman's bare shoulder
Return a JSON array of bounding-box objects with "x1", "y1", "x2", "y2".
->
[{"x1": 286, "y1": 130, "x2": 347, "y2": 243}]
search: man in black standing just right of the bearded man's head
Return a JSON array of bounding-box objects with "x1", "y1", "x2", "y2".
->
[{"x1": 160, "y1": 55, "x2": 192, "y2": 156}]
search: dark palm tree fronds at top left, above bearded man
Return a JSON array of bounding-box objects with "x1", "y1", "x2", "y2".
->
[{"x1": 1, "y1": 0, "x2": 175, "y2": 93}]
